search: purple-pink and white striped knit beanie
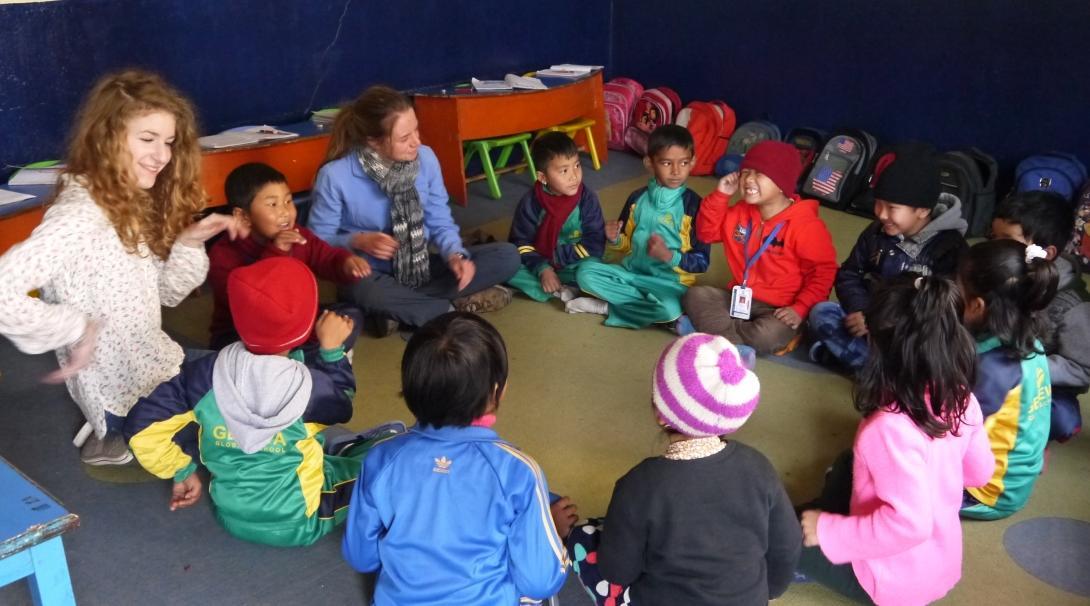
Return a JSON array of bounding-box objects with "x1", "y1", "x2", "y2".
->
[{"x1": 652, "y1": 332, "x2": 761, "y2": 437}]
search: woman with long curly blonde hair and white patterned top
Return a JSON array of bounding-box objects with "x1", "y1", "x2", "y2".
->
[{"x1": 0, "y1": 70, "x2": 247, "y2": 464}]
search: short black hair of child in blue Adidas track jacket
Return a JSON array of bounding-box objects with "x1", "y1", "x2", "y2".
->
[{"x1": 401, "y1": 312, "x2": 507, "y2": 427}]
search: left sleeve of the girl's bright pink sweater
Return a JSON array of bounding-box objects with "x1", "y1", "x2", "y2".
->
[{"x1": 818, "y1": 413, "x2": 933, "y2": 563}]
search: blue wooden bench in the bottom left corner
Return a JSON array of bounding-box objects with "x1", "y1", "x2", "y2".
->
[{"x1": 0, "y1": 457, "x2": 80, "y2": 606}]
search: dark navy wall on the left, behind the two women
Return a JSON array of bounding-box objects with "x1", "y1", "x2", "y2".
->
[{"x1": 0, "y1": 0, "x2": 610, "y2": 169}]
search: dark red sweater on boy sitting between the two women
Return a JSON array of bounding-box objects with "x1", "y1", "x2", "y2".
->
[{"x1": 208, "y1": 226, "x2": 355, "y2": 349}]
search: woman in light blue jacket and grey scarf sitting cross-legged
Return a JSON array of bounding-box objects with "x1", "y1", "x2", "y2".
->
[{"x1": 308, "y1": 86, "x2": 519, "y2": 336}]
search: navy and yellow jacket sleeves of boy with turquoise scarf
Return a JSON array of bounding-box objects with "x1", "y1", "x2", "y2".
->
[{"x1": 609, "y1": 186, "x2": 712, "y2": 286}]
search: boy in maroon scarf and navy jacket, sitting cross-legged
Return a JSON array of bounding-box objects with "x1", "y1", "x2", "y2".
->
[{"x1": 508, "y1": 132, "x2": 605, "y2": 303}]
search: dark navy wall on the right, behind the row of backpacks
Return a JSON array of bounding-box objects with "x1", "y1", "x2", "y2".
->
[{"x1": 610, "y1": 0, "x2": 1090, "y2": 177}]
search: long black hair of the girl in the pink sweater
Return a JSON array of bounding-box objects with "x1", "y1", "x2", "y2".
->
[{"x1": 853, "y1": 272, "x2": 977, "y2": 438}]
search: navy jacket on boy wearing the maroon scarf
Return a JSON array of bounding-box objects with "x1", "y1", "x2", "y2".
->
[{"x1": 507, "y1": 185, "x2": 606, "y2": 271}]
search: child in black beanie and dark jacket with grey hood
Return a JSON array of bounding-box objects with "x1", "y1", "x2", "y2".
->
[{"x1": 810, "y1": 143, "x2": 968, "y2": 372}]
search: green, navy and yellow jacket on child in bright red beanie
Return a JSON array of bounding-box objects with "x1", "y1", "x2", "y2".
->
[{"x1": 123, "y1": 348, "x2": 355, "y2": 545}]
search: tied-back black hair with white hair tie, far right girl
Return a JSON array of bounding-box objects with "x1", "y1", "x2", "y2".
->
[{"x1": 958, "y1": 240, "x2": 1059, "y2": 357}]
